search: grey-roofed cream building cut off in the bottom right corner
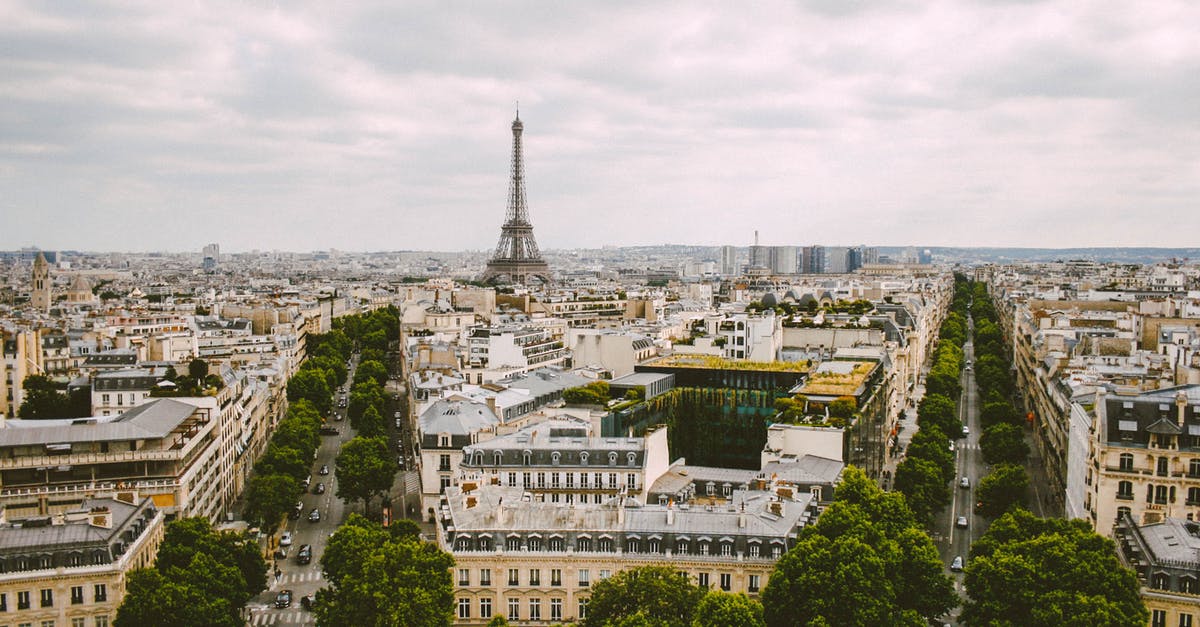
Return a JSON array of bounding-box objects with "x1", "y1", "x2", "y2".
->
[{"x1": 1112, "y1": 514, "x2": 1200, "y2": 627}]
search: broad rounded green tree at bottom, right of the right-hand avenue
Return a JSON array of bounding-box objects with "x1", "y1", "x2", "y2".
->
[{"x1": 962, "y1": 509, "x2": 1150, "y2": 627}]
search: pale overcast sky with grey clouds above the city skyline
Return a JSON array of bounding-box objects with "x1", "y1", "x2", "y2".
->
[{"x1": 0, "y1": 0, "x2": 1200, "y2": 251}]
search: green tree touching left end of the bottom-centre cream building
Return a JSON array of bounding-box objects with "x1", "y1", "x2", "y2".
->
[{"x1": 313, "y1": 514, "x2": 454, "y2": 627}]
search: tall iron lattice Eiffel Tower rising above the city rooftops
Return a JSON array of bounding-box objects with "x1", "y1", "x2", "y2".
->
[{"x1": 479, "y1": 109, "x2": 550, "y2": 283}]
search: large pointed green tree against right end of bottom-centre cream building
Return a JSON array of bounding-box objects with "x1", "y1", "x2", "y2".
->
[{"x1": 762, "y1": 466, "x2": 956, "y2": 627}]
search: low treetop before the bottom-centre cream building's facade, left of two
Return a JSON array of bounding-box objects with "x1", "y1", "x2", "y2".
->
[{"x1": 580, "y1": 566, "x2": 704, "y2": 627}]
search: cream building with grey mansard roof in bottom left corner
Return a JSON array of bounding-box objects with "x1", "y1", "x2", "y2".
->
[{"x1": 0, "y1": 498, "x2": 164, "y2": 627}]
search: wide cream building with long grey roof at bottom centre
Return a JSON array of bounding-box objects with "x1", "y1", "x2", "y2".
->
[{"x1": 438, "y1": 483, "x2": 816, "y2": 626}]
